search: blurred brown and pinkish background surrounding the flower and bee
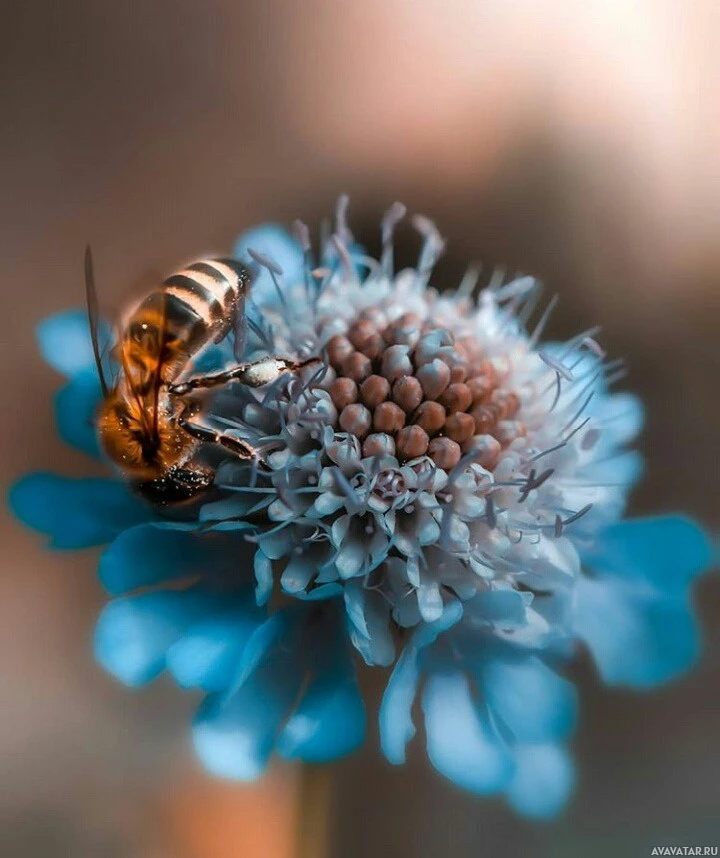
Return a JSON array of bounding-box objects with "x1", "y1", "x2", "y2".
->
[{"x1": 0, "y1": 0, "x2": 720, "y2": 858}]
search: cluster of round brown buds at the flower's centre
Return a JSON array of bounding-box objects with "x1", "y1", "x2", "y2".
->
[{"x1": 326, "y1": 309, "x2": 526, "y2": 470}]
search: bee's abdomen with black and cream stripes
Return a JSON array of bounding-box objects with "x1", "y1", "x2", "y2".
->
[{"x1": 123, "y1": 259, "x2": 250, "y2": 388}]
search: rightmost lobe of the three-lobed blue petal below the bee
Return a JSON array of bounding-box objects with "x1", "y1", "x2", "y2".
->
[{"x1": 167, "y1": 599, "x2": 263, "y2": 691}]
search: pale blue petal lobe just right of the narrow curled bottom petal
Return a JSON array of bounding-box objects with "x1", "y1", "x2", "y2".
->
[{"x1": 422, "y1": 672, "x2": 513, "y2": 795}]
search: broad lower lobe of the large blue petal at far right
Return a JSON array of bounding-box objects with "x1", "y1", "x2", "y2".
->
[{"x1": 575, "y1": 579, "x2": 700, "y2": 688}]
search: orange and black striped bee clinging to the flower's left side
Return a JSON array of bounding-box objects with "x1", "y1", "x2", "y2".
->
[{"x1": 85, "y1": 247, "x2": 305, "y2": 506}]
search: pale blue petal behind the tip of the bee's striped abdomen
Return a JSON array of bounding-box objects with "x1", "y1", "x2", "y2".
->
[{"x1": 233, "y1": 224, "x2": 304, "y2": 313}]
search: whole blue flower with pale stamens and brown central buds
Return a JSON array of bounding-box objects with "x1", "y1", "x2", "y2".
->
[{"x1": 11, "y1": 198, "x2": 711, "y2": 816}]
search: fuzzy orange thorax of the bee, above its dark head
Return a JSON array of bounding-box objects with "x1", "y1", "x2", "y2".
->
[{"x1": 97, "y1": 390, "x2": 195, "y2": 481}]
